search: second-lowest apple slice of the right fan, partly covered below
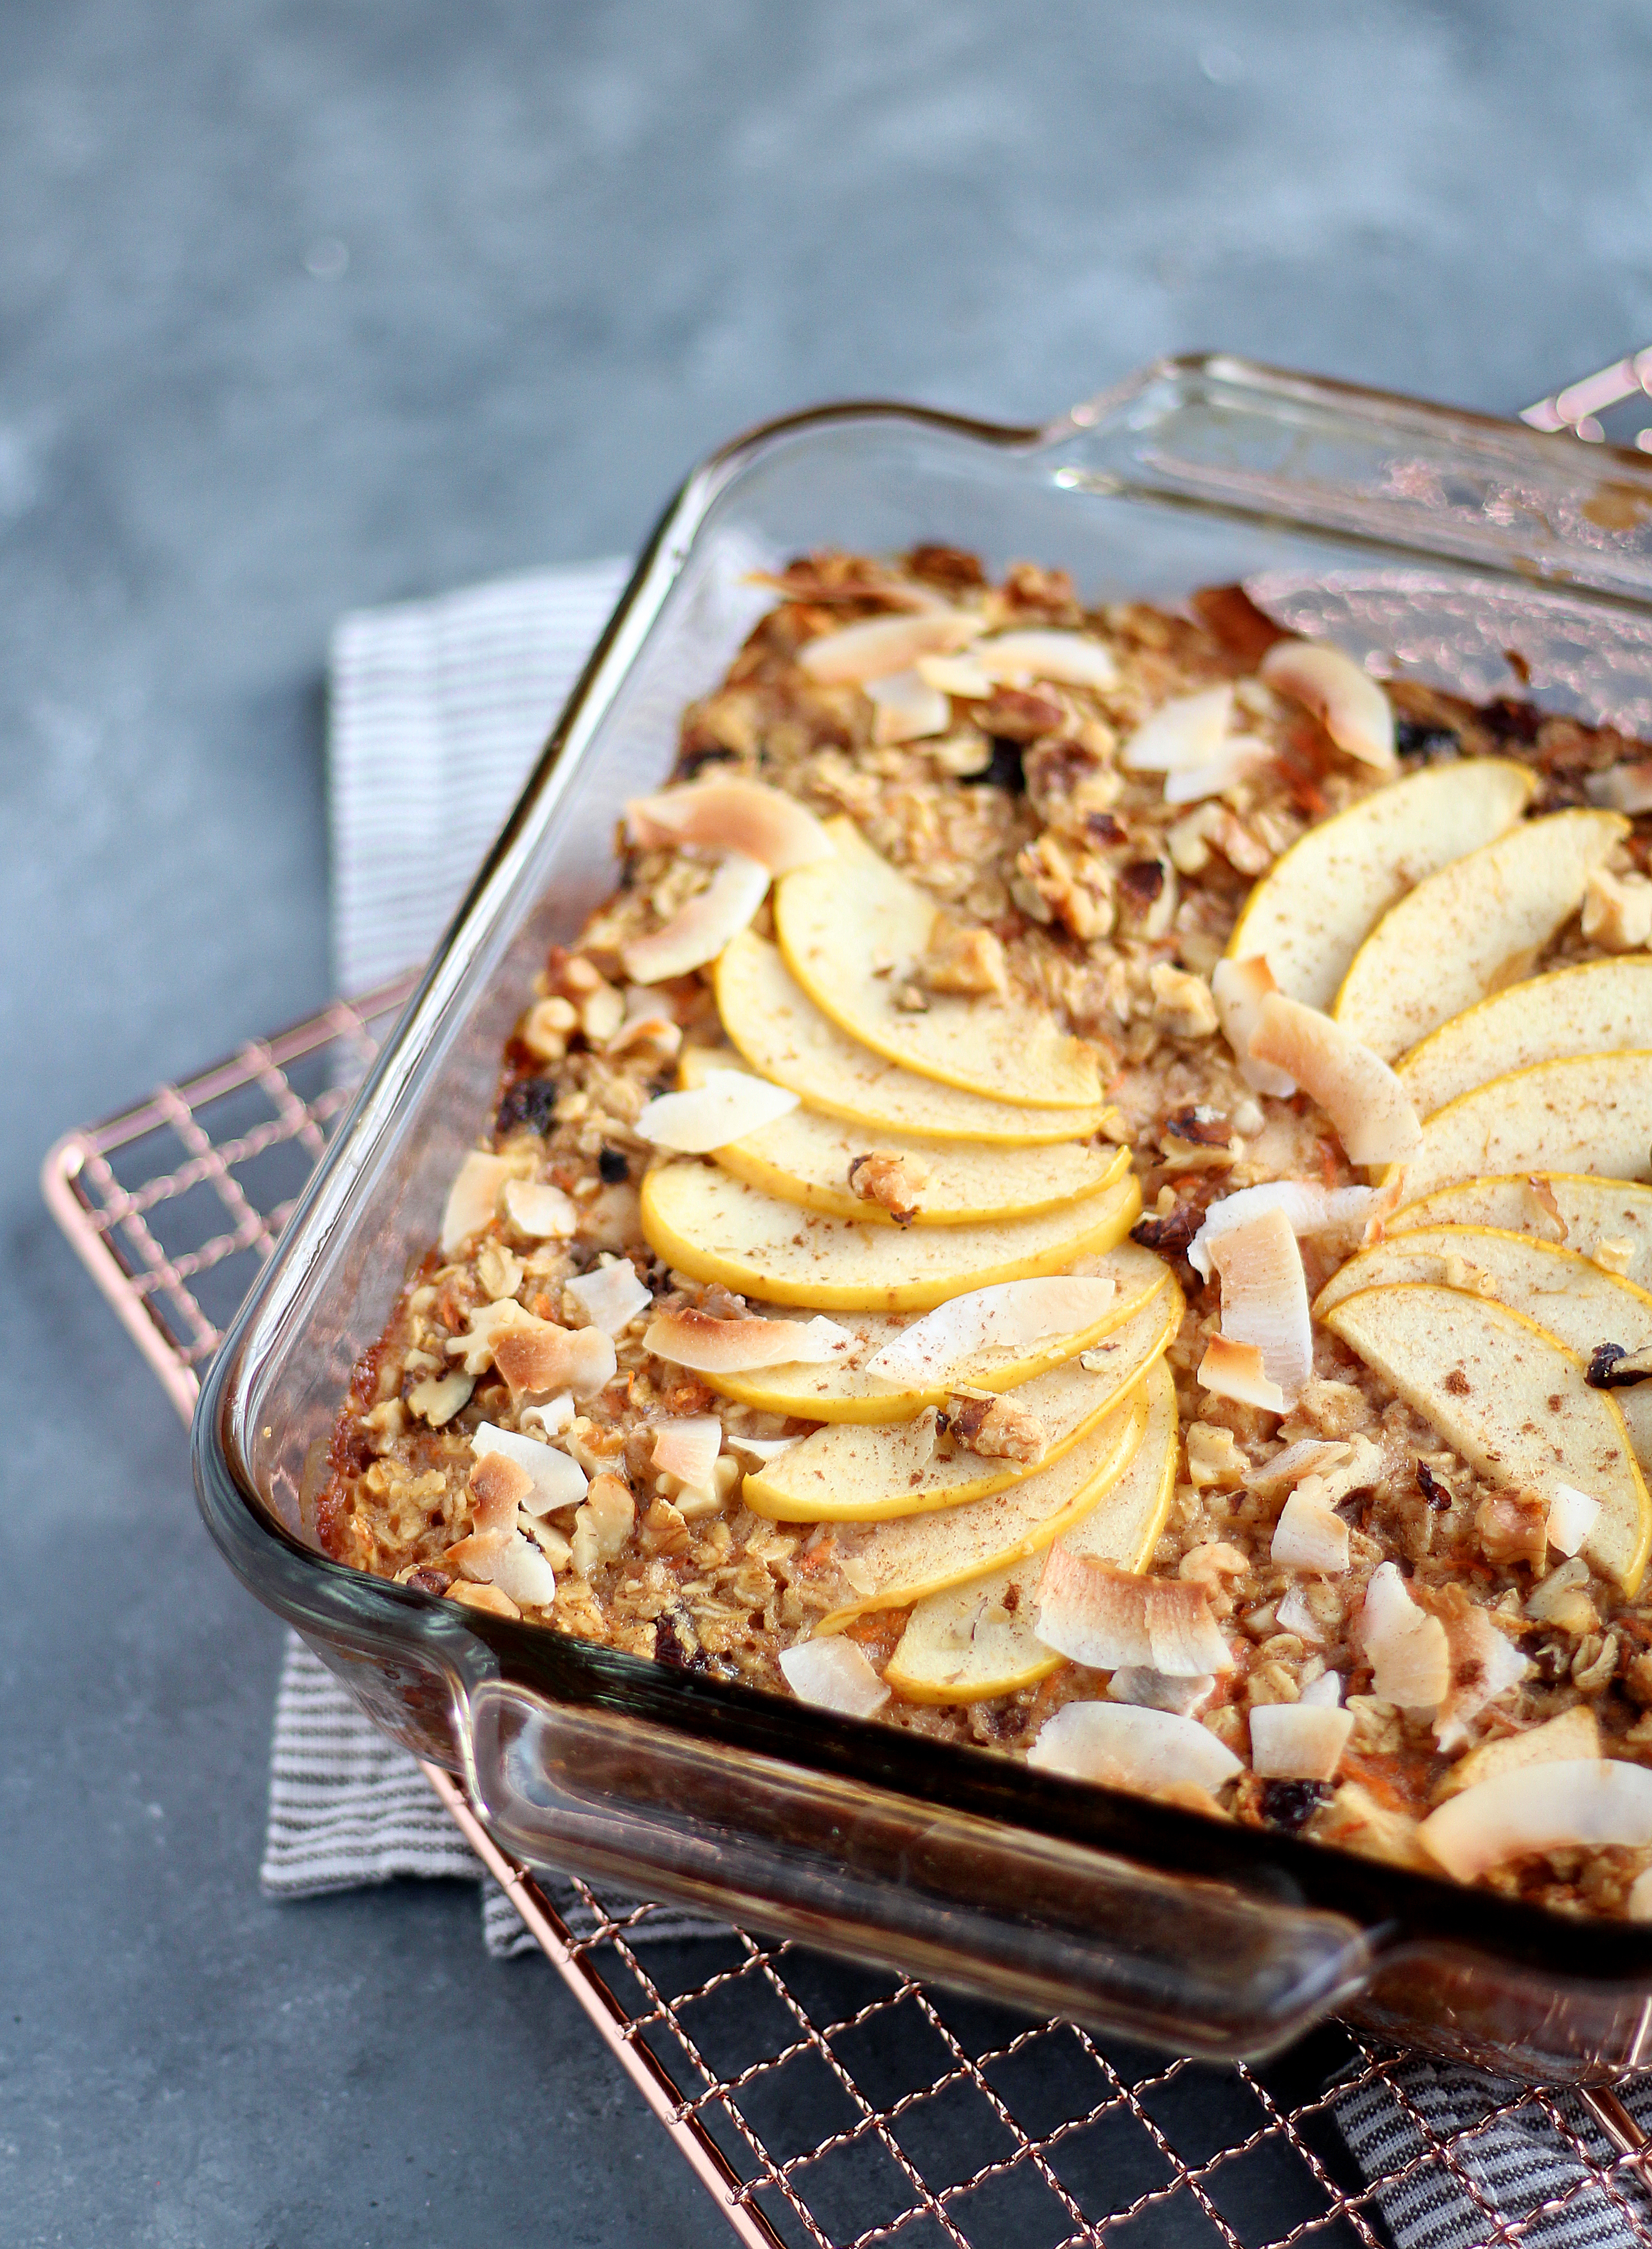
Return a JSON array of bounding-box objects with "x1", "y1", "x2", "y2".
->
[{"x1": 1313, "y1": 1226, "x2": 1652, "y2": 1469}]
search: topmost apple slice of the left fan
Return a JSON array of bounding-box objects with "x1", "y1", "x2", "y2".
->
[{"x1": 773, "y1": 819, "x2": 1101, "y2": 1109}]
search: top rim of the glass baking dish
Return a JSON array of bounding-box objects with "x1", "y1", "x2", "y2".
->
[{"x1": 191, "y1": 353, "x2": 1652, "y2": 1986}]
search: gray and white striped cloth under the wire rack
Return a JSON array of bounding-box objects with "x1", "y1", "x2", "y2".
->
[{"x1": 261, "y1": 560, "x2": 1652, "y2": 2249}]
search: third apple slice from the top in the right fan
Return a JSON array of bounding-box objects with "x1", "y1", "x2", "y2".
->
[{"x1": 1393, "y1": 953, "x2": 1652, "y2": 1118}]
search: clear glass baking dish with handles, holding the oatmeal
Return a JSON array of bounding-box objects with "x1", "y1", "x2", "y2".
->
[{"x1": 193, "y1": 355, "x2": 1652, "y2": 2080}]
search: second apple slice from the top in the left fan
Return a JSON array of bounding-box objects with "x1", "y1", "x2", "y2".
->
[{"x1": 717, "y1": 931, "x2": 1115, "y2": 1147}]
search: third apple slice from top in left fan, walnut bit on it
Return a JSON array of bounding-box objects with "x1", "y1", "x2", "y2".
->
[{"x1": 679, "y1": 1046, "x2": 1130, "y2": 1226}]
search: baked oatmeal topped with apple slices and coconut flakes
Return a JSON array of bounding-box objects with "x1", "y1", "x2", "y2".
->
[{"x1": 317, "y1": 546, "x2": 1652, "y2": 1919}]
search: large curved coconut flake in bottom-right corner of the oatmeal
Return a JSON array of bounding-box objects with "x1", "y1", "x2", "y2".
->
[{"x1": 1418, "y1": 1757, "x2": 1652, "y2": 1882}]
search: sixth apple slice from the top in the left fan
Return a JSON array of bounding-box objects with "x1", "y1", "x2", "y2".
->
[{"x1": 744, "y1": 1282, "x2": 1182, "y2": 1523}]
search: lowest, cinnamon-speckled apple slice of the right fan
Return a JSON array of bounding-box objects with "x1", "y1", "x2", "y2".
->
[{"x1": 1324, "y1": 1282, "x2": 1652, "y2": 1592}]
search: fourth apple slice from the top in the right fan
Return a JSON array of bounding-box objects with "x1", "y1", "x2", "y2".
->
[{"x1": 1382, "y1": 1050, "x2": 1652, "y2": 1203}]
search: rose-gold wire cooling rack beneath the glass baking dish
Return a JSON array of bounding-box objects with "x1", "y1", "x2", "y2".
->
[{"x1": 45, "y1": 978, "x2": 1652, "y2": 2249}]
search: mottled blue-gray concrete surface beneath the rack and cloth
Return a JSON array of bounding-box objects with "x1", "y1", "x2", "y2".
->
[{"x1": 0, "y1": 0, "x2": 1652, "y2": 2249}]
